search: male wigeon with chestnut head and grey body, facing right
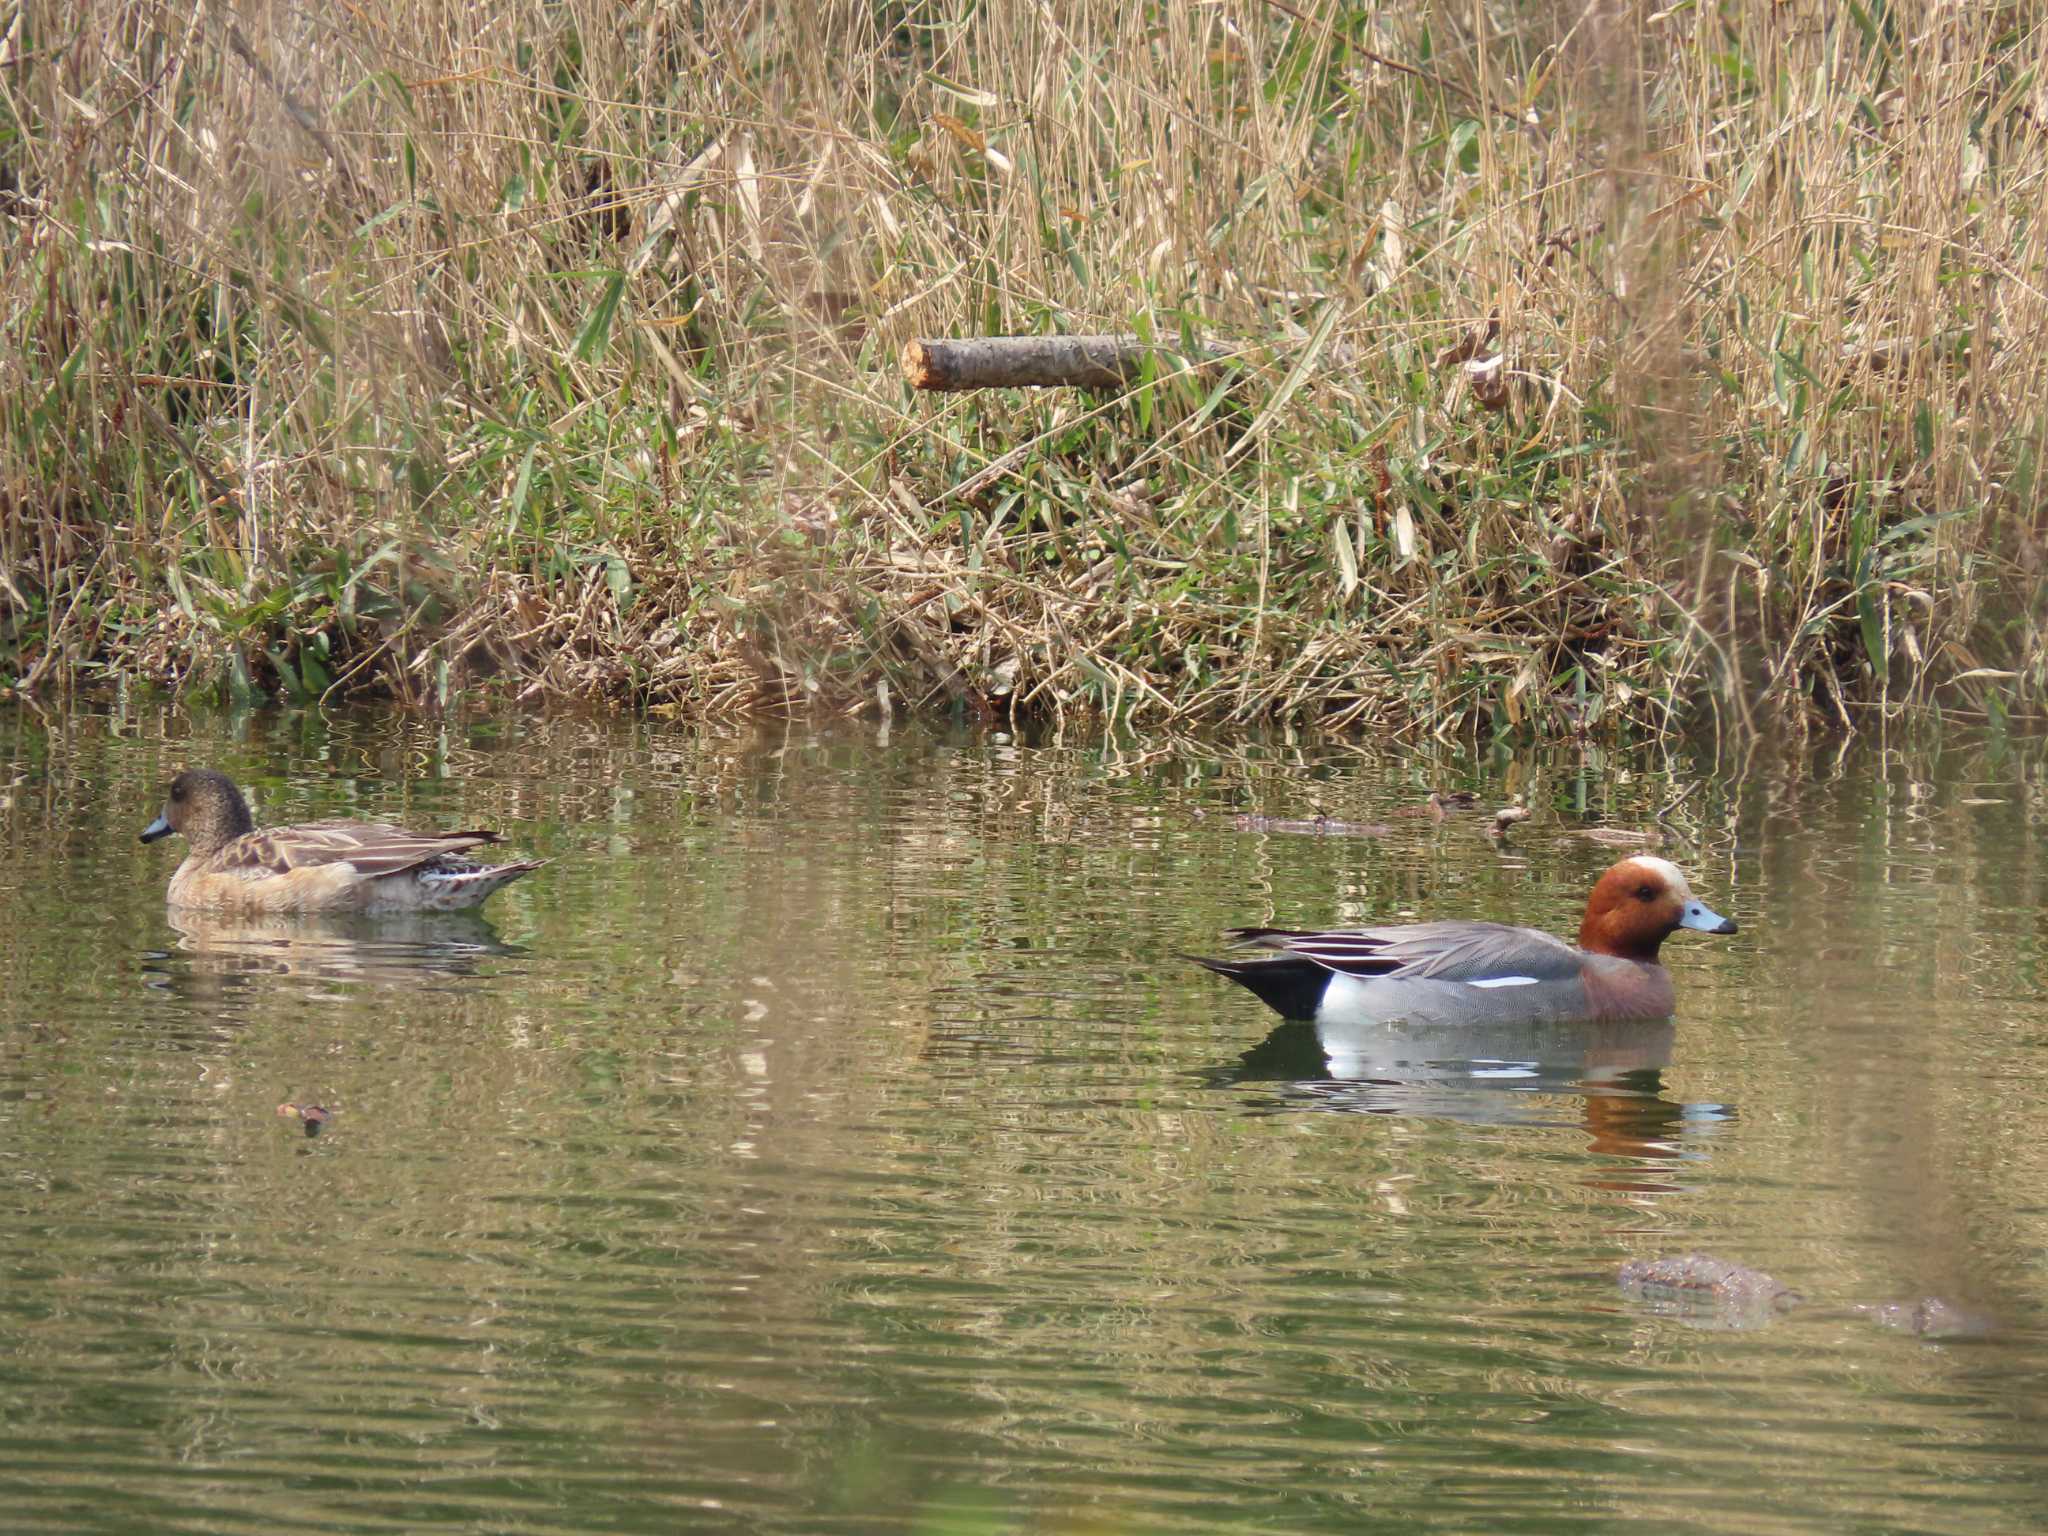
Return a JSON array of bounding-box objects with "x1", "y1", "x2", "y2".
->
[{"x1": 1188, "y1": 854, "x2": 1735, "y2": 1024}]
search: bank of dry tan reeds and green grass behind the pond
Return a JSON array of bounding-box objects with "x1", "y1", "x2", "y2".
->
[{"x1": 0, "y1": 0, "x2": 2048, "y2": 731}]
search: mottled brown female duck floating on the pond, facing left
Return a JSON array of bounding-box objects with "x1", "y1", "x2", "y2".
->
[{"x1": 141, "y1": 768, "x2": 547, "y2": 911}]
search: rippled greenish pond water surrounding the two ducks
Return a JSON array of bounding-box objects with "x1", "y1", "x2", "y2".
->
[{"x1": 0, "y1": 707, "x2": 2048, "y2": 1534}]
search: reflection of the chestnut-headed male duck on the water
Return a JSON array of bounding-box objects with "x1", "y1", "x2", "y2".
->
[{"x1": 1208, "y1": 1018, "x2": 1735, "y2": 1194}]
